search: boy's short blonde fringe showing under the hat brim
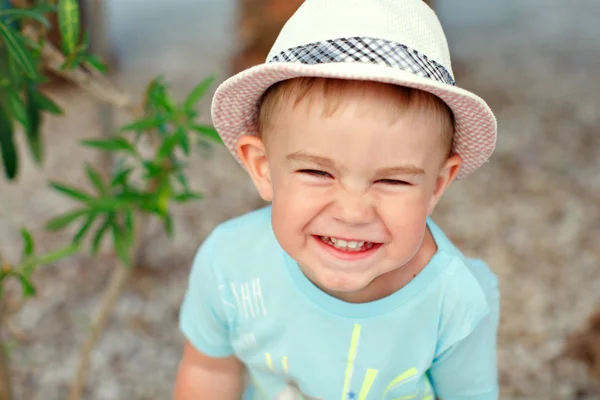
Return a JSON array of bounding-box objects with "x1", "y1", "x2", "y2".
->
[{"x1": 257, "y1": 77, "x2": 455, "y2": 156}]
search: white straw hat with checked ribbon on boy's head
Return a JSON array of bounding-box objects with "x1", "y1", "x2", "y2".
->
[{"x1": 212, "y1": 0, "x2": 497, "y2": 178}]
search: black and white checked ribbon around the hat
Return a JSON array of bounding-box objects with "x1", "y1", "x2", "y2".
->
[{"x1": 269, "y1": 37, "x2": 456, "y2": 86}]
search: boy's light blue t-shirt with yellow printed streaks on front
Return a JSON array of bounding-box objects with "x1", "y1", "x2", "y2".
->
[{"x1": 180, "y1": 207, "x2": 499, "y2": 400}]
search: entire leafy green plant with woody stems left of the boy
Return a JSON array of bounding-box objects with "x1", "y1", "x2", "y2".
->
[{"x1": 0, "y1": 0, "x2": 220, "y2": 400}]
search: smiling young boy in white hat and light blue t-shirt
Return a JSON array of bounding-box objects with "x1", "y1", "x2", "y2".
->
[{"x1": 175, "y1": 0, "x2": 499, "y2": 400}]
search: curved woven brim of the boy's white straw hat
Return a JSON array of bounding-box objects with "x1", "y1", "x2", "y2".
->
[{"x1": 211, "y1": 62, "x2": 497, "y2": 179}]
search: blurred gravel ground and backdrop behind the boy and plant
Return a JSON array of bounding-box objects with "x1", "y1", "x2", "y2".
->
[{"x1": 0, "y1": 0, "x2": 600, "y2": 400}]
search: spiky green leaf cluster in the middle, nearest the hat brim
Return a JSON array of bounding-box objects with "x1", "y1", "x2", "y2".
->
[{"x1": 47, "y1": 77, "x2": 219, "y2": 265}]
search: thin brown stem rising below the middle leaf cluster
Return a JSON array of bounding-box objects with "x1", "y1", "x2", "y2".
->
[{"x1": 67, "y1": 214, "x2": 148, "y2": 400}]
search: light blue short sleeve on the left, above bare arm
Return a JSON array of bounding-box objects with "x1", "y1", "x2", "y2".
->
[{"x1": 179, "y1": 235, "x2": 233, "y2": 357}]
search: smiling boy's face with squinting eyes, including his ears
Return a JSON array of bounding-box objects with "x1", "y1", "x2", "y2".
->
[{"x1": 239, "y1": 83, "x2": 460, "y2": 297}]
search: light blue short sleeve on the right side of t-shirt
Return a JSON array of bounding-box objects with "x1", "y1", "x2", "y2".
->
[{"x1": 429, "y1": 262, "x2": 500, "y2": 400}]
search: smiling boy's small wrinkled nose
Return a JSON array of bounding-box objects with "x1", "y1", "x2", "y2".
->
[{"x1": 332, "y1": 189, "x2": 375, "y2": 225}]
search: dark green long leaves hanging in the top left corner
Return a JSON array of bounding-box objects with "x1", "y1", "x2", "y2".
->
[{"x1": 0, "y1": 0, "x2": 96, "y2": 180}]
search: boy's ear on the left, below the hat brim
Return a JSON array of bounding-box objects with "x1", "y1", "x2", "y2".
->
[{"x1": 237, "y1": 135, "x2": 273, "y2": 201}]
